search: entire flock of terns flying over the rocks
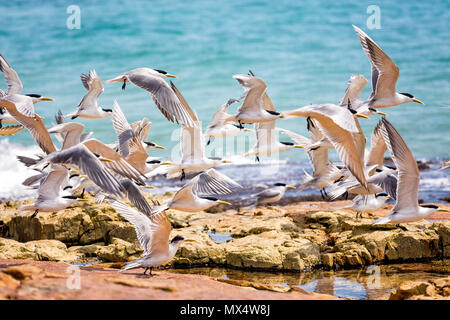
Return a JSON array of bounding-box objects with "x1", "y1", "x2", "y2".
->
[{"x1": 0, "y1": 26, "x2": 447, "y2": 274}]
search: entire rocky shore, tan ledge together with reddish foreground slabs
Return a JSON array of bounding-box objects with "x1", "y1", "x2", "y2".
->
[{"x1": 0, "y1": 194, "x2": 450, "y2": 299}]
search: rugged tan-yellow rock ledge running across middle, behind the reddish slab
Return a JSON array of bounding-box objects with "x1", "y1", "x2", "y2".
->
[{"x1": 0, "y1": 194, "x2": 450, "y2": 271}]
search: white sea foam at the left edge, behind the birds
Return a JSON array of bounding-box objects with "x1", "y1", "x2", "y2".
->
[{"x1": 0, "y1": 138, "x2": 40, "y2": 201}]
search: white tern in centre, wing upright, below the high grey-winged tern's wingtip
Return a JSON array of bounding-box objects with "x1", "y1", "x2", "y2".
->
[{"x1": 163, "y1": 82, "x2": 230, "y2": 180}]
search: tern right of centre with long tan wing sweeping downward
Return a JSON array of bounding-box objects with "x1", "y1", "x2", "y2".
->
[{"x1": 283, "y1": 104, "x2": 367, "y2": 188}]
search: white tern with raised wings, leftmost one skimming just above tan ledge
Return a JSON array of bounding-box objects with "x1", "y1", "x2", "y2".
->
[{"x1": 18, "y1": 164, "x2": 86, "y2": 218}]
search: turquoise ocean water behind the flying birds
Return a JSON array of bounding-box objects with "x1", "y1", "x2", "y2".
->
[{"x1": 0, "y1": 0, "x2": 450, "y2": 201}]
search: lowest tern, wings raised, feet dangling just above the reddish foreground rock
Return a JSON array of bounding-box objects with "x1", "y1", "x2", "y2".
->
[{"x1": 109, "y1": 199, "x2": 194, "y2": 275}]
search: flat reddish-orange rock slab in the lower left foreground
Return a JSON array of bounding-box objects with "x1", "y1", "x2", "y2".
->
[{"x1": 0, "y1": 259, "x2": 335, "y2": 300}]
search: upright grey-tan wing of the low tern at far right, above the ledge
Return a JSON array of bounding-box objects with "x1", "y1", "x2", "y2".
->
[{"x1": 380, "y1": 118, "x2": 420, "y2": 212}]
